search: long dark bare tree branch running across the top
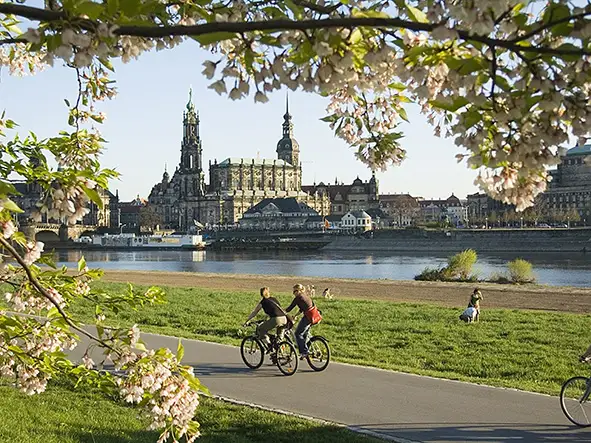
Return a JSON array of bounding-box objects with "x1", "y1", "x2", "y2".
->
[{"x1": 0, "y1": 3, "x2": 591, "y2": 56}]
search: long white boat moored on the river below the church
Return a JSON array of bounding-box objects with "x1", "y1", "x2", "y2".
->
[{"x1": 87, "y1": 234, "x2": 205, "y2": 250}]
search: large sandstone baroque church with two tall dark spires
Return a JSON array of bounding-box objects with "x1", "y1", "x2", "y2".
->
[{"x1": 148, "y1": 92, "x2": 330, "y2": 230}]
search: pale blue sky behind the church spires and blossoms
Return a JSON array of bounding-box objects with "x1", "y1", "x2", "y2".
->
[{"x1": 0, "y1": 42, "x2": 477, "y2": 200}]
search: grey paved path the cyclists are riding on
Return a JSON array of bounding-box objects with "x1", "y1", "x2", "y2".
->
[{"x1": 80, "y1": 333, "x2": 591, "y2": 443}]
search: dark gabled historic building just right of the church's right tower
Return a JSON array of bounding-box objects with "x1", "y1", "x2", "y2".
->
[{"x1": 302, "y1": 173, "x2": 380, "y2": 215}]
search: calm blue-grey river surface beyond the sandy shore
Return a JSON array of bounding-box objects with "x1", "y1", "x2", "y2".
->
[{"x1": 56, "y1": 251, "x2": 591, "y2": 287}]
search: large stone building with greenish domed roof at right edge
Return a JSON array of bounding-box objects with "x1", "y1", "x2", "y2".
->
[{"x1": 544, "y1": 145, "x2": 591, "y2": 219}]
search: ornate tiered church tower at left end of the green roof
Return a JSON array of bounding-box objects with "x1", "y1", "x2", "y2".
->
[{"x1": 179, "y1": 90, "x2": 205, "y2": 196}]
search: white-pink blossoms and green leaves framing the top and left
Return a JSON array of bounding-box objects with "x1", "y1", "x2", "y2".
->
[{"x1": 0, "y1": 0, "x2": 591, "y2": 439}]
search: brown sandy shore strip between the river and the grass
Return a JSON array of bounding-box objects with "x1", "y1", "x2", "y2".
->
[{"x1": 104, "y1": 271, "x2": 591, "y2": 313}]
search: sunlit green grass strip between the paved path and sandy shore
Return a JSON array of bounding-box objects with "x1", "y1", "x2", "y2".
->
[{"x1": 75, "y1": 283, "x2": 591, "y2": 394}]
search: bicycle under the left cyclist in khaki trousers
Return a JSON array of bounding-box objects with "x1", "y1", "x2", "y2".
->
[{"x1": 240, "y1": 320, "x2": 298, "y2": 376}]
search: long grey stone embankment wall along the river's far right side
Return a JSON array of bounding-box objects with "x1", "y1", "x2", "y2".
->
[{"x1": 323, "y1": 228, "x2": 591, "y2": 253}]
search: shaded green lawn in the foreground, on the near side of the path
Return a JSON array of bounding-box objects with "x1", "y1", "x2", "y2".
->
[{"x1": 0, "y1": 383, "x2": 377, "y2": 443}]
